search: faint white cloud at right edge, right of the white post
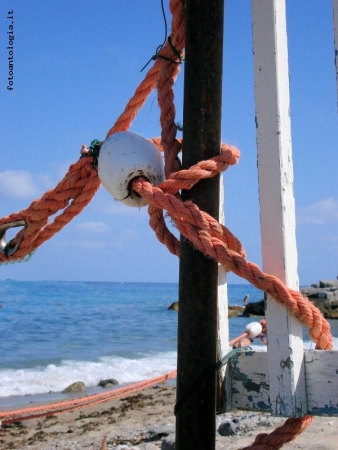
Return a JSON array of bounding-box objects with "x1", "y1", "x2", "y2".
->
[{"x1": 297, "y1": 197, "x2": 338, "y2": 225}]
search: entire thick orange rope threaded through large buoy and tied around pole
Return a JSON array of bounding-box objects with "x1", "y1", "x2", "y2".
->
[{"x1": 0, "y1": 0, "x2": 332, "y2": 450}]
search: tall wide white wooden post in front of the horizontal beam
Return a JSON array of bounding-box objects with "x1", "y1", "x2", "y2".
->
[{"x1": 252, "y1": 0, "x2": 307, "y2": 417}]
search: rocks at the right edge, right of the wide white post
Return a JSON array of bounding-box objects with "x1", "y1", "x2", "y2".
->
[{"x1": 300, "y1": 280, "x2": 338, "y2": 319}]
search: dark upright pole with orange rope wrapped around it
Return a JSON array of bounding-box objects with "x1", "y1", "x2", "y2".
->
[{"x1": 175, "y1": 0, "x2": 224, "y2": 450}]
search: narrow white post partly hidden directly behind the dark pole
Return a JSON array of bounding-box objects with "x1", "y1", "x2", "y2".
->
[{"x1": 217, "y1": 174, "x2": 229, "y2": 413}]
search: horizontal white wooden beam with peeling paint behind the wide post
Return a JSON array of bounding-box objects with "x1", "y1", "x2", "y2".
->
[{"x1": 229, "y1": 350, "x2": 338, "y2": 417}]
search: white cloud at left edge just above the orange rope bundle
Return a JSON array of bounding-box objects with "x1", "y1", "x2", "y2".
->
[{"x1": 0, "y1": 170, "x2": 39, "y2": 199}]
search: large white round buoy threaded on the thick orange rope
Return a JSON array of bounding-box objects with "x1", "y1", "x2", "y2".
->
[{"x1": 98, "y1": 131, "x2": 164, "y2": 207}]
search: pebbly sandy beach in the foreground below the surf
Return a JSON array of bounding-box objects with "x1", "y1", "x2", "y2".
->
[{"x1": 0, "y1": 384, "x2": 338, "y2": 450}]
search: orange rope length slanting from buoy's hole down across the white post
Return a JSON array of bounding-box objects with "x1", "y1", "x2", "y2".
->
[{"x1": 132, "y1": 178, "x2": 332, "y2": 350}]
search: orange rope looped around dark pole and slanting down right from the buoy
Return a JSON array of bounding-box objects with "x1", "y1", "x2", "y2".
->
[{"x1": 132, "y1": 155, "x2": 332, "y2": 350}]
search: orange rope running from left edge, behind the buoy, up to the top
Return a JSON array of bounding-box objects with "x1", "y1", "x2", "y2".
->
[{"x1": 0, "y1": 0, "x2": 185, "y2": 264}]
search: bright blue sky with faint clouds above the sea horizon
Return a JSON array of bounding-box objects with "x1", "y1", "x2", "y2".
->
[{"x1": 0, "y1": 0, "x2": 338, "y2": 284}]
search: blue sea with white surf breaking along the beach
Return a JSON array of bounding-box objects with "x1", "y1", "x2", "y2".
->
[{"x1": 0, "y1": 280, "x2": 338, "y2": 407}]
